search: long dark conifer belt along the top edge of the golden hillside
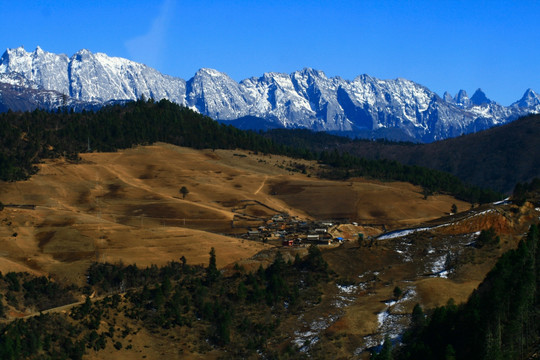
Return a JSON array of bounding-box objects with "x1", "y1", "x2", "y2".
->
[{"x1": 0, "y1": 100, "x2": 500, "y2": 202}]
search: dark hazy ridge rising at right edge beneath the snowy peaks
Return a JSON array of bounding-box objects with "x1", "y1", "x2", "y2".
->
[{"x1": 330, "y1": 115, "x2": 540, "y2": 193}]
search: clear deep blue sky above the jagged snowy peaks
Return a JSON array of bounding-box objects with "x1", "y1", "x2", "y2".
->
[{"x1": 0, "y1": 0, "x2": 540, "y2": 105}]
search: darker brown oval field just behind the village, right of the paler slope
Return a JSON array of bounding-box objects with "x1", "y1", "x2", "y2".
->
[{"x1": 270, "y1": 178, "x2": 470, "y2": 228}]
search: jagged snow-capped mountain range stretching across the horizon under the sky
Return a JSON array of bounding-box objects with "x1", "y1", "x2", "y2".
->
[{"x1": 0, "y1": 47, "x2": 540, "y2": 142}]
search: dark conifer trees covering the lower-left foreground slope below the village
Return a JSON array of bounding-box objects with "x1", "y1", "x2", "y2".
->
[{"x1": 0, "y1": 246, "x2": 332, "y2": 360}]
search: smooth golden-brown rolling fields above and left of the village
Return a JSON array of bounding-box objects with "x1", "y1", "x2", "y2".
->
[{"x1": 0, "y1": 144, "x2": 468, "y2": 283}]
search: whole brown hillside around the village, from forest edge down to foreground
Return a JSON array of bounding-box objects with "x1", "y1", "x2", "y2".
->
[{"x1": 0, "y1": 143, "x2": 540, "y2": 359}]
